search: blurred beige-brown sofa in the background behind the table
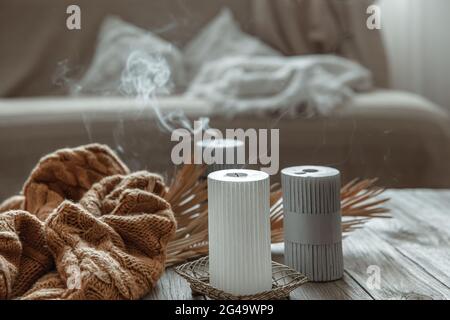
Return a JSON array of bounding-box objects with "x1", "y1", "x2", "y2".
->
[{"x1": 0, "y1": 0, "x2": 450, "y2": 199}]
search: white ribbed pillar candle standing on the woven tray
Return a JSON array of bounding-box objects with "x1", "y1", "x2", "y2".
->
[{"x1": 208, "y1": 169, "x2": 272, "y2": 295}]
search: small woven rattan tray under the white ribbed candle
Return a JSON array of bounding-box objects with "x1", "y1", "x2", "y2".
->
[{"x1": 175, "y1": 256, "x2": 308, "y2": 300}]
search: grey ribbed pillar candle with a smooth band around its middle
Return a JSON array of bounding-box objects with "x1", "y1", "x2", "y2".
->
[{"x1": 281, "y1": 166, "x2": 344, "y2": 281}]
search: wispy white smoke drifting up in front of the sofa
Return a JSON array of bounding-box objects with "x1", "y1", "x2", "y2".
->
[{"x1": 52, "y1": 50, "x2": 209, "y2": 169}]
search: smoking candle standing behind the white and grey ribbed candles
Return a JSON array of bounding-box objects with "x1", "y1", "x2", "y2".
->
[{"x1": 196, "y1": 139, "x2": 244, "y2": 177}]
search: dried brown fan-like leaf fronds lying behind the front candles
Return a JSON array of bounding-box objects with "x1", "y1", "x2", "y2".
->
[{"x1": 165, "y1": 164, "x2": 390, "y2": 266}]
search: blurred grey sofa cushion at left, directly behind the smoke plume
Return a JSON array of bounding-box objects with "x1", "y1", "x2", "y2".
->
[{"x1": 75, "y1": 17, "x2": 184, "y2": 95}]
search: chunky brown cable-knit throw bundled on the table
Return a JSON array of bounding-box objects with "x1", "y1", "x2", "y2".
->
[{"x1": 0, "y1": 144, "x2": 176, "y2": 299}]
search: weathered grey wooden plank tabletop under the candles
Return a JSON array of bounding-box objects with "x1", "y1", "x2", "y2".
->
[{"x1": 146, "y1": 189, "x2": 450, "y2": 300}]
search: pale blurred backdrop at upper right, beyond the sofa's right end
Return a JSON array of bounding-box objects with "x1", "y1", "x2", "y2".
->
[{"x1": 379, "y1": 0, "x2": 450, "y2": 111}]
